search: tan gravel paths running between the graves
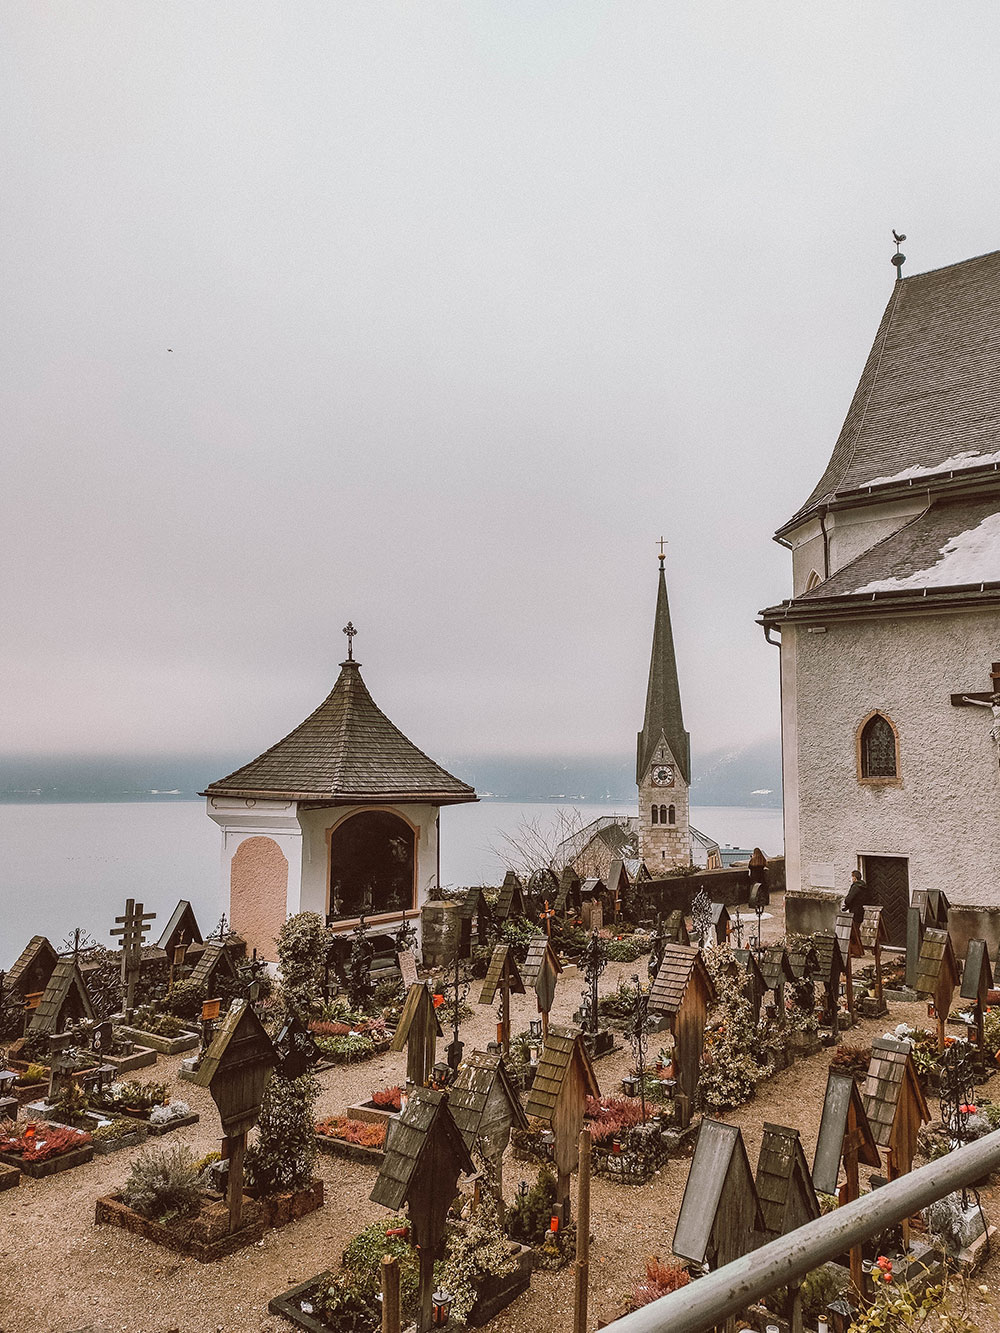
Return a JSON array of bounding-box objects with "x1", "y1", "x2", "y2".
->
[{"x1": 0, "y1": 912, "x2": 1000, "y2": 1333}]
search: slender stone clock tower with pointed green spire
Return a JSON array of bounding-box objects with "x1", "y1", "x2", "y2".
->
[{"x1": 636, "y1": 543, "x2": 691, "y2": 876}]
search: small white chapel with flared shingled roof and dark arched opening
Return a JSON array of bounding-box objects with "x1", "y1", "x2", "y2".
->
[{"x1": 201, "y1": 624, "x2": 477, "y2": 961}]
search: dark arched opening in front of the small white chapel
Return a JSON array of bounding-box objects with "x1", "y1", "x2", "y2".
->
[{"x1": 328, "y1": 810, "x2": 416, "y2": 921}]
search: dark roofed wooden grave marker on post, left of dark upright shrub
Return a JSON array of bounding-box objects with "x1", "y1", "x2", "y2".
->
[{"x1": 193, "y1": 1000, "x2": 279, "y2": 1232}]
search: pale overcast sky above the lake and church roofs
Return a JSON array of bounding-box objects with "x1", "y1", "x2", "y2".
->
[{"x1": 0, "y1": 0, "x2": 1000, "y2": 757}]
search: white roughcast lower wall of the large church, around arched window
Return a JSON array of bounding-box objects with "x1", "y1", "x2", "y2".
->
[{"x1": 783, "y1": 612, "x2": 1000, "y2": 905}]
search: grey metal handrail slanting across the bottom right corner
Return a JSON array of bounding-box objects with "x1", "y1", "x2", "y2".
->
[{"x1": 609, "y1": 1129, "x2": 1000, "y2": 1333}]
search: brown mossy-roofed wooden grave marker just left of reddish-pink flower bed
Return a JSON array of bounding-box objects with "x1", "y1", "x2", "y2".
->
[{"x1": 524, "y1": 1024, "x2": 600, "y2": 1225}]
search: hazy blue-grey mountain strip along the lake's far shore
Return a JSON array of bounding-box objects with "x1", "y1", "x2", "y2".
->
[{"x1": 0, "y1": 740, "x2": 781, "y2": 808}]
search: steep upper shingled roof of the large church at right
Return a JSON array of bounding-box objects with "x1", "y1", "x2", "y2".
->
[{"x1": 781, "y1": 251, "x2": 1000, "y2": 532}]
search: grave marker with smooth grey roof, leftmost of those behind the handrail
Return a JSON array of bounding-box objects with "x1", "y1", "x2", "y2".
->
[{"x1": 673, "y1": 1117, "x2": 767, "y2": 1270}]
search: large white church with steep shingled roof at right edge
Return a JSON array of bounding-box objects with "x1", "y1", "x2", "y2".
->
[{"x1": 760, "y1": 252, "x2": 1000, "y2": 952}]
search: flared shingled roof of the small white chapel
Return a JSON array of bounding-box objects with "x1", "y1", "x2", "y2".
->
[{"x1": 203, "y1": 661, "x2": 477, "y2": 805}]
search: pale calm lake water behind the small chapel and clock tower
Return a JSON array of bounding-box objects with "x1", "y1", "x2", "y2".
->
[{"x1": 0, "y1": 801, "x2": 783, "y2": 968}]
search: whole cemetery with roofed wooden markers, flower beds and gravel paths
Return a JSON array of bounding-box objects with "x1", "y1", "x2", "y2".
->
[{"x1": 0, "y1": 870, "x2": 1000, "y2": 1333}]
